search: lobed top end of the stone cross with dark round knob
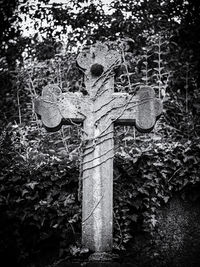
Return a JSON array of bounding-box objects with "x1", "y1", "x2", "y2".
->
[{"x1": 76, "y1": 42, "x2": 121, "y2": 78}]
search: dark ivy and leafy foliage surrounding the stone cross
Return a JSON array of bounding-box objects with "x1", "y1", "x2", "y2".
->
[{"x1": 0, "y1": 0, "x2": 200, "y2": 267}]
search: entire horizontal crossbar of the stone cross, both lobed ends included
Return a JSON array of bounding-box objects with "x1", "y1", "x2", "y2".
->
[{"x1": 35, "y1": 86, "x2": 162, "y2": 132}]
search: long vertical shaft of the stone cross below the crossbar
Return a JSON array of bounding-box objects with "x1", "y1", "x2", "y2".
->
[{"x1": 82, "y1": 80, "x2": 114, "y2": 252}]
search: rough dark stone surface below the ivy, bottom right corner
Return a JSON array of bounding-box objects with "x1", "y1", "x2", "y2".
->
[{"x1": 123, "y1": 195, "x2": 200, "y2": 267}]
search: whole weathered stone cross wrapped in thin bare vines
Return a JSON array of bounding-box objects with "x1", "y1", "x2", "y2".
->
[{"x1": 35, "y1": 43, "x2": 162, "y2": 255}]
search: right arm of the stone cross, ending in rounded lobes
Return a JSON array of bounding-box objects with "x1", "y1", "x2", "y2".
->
[{"x1": 112, "y1": 86, "x2": 162, "y2": 132}]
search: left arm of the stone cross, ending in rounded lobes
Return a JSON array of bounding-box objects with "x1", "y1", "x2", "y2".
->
[{"x1": 34, "y1": 85, "x2": 88, "y2": 128}]
